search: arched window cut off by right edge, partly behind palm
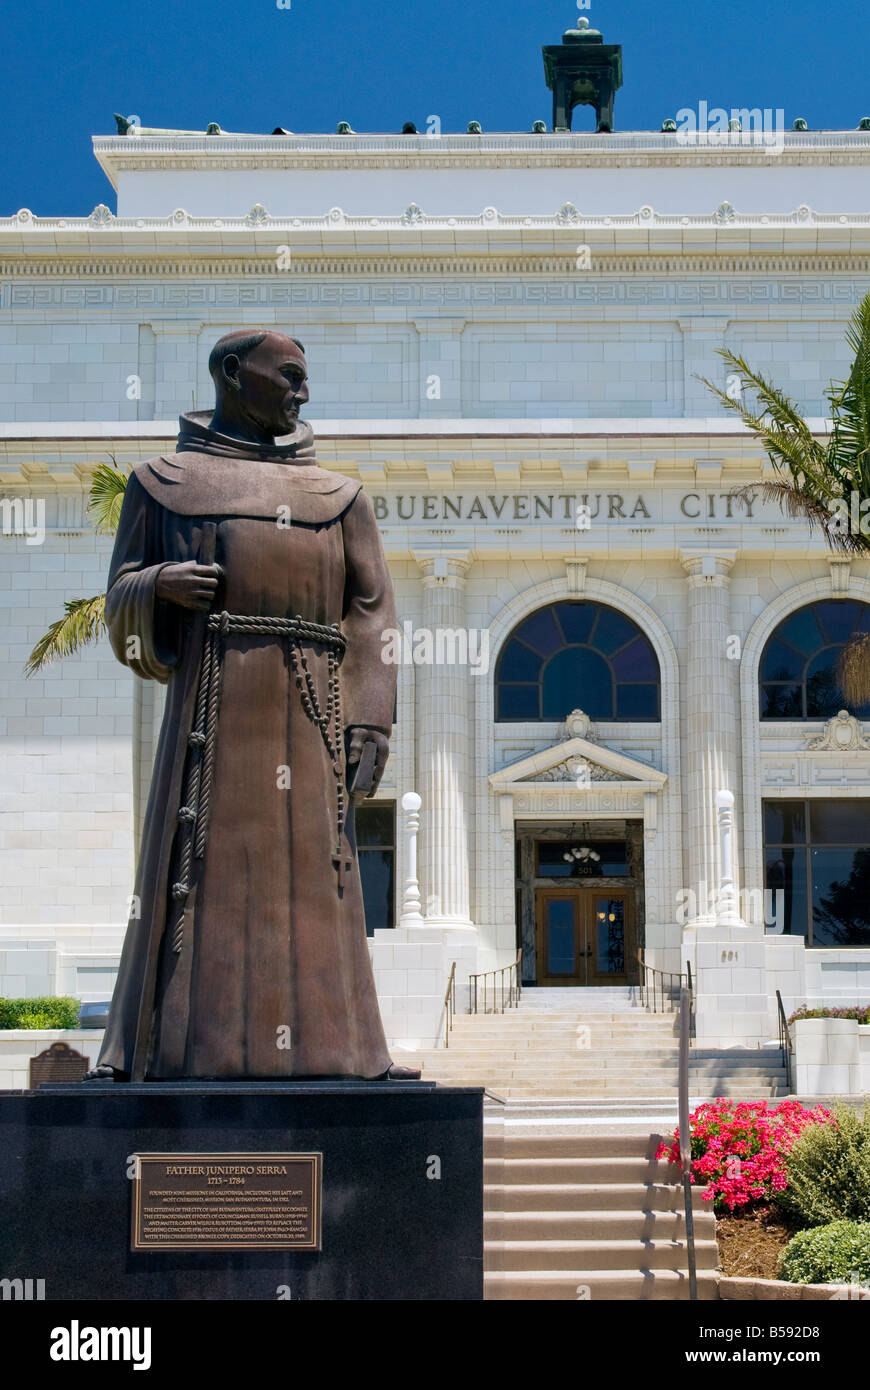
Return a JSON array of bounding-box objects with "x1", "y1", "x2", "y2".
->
[{"x1": 759, "y1": 599, "x2": 870, "y2": 719}]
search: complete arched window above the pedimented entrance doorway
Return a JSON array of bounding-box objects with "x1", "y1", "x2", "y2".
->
[{"x1": 495, "y1": 600, "x2": 662, "y2": 721}]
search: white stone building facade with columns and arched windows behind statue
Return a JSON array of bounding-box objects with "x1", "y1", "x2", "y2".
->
[{"x1": 0, "y1": 132, "x2": 870, "y2": 1047}]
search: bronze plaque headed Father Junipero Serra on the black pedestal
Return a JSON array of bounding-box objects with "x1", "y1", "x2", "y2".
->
[{"x1": 131, "y1": 1154, "x2": 322, "y2": 1250}]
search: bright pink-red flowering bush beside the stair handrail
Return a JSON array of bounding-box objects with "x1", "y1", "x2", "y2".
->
[{"x1": 656, "y1": 1099, "x2": 832, "y2": 1212}]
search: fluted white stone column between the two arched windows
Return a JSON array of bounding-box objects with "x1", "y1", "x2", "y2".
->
[{"x1": 681, "y1": 550, "x2": 738, "y2": 924}]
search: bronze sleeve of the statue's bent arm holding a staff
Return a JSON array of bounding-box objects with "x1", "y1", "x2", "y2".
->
[{"x1": 106, "y1": 473, "x2": 181, "y2": 685}]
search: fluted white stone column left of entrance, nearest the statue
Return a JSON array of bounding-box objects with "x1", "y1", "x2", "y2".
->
[{"x1": 414, "y1": 550, "x2": 475, "y2": 930}]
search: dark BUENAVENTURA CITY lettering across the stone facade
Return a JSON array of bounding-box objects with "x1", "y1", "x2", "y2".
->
[{"x1": 371, "y1": 492, "x2": 757, "y2": 525}]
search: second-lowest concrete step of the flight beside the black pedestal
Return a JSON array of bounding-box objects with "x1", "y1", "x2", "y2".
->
[{"x1": 484, "y1": 1240, "x2": 719, "y2": 1270}]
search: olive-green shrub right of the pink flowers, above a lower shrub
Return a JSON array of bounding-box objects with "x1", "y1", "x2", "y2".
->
[{"x1": 775, "y1": 1105, "x2": 870, "y2": 1226}]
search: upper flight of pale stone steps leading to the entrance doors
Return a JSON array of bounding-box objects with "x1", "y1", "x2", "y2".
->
[{"x1": 414, "y1": 987, "x2": 785, "y2": 1101}]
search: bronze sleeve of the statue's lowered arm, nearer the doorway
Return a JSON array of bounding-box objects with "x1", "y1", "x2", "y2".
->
[{"x1": 342, "y1": 491, "x2": 396, "y2": 734}]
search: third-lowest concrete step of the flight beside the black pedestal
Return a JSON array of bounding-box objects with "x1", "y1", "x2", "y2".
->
[{"x1": 484, "y1": 1207, "x2": 716, "y2": 1245}]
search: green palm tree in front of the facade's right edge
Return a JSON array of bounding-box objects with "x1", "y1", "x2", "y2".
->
[{"x1": 700, "y1": 295, "x2": 870, "y2": 705}]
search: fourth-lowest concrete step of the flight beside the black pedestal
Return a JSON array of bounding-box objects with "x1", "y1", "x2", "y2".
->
[{"x1": 485, "y1": 1170, "x2": 700, "y2": 1212}]
